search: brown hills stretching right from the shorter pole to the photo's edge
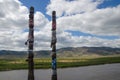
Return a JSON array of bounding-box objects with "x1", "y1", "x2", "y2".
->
[{"x1": 57, "y1": 47, "x2": 120, "y2": 57}]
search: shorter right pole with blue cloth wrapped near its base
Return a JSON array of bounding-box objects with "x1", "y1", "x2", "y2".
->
[{"x1": 51, "y1": 11, "x2": 57, "y2": 80}]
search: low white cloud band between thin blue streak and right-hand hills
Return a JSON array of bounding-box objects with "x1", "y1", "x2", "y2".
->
[{"x1": 57, "y1": 32, "x2": 120, "y2": 48}]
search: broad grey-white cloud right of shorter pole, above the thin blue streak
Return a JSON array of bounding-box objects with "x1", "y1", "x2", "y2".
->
[{"x1": 57, "y1": 5, "x2": 120, "y2": 36}]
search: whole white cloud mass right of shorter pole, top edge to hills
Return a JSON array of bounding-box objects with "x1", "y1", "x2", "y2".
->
[{"x1": 47, "y1": 0, "x2": 120, "y2": 48}]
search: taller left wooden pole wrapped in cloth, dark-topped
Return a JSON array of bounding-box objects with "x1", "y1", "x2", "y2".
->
[{"x1": 25, "y1": 7, "x2": 34, "y2": 80}]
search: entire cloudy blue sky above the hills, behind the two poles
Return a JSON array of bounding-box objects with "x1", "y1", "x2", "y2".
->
[{"x1": 0, "y1": 0, "x2": 120, "y2": 51}]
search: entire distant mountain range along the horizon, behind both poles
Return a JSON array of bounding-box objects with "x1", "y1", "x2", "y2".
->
[{"x1": 0, "y1": 47, "x2": 120, "y2": 58}]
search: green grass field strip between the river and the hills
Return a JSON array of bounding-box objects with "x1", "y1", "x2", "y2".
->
[{"x1": 0, "y1": 55, "x2": 120, "y2": 71}]
